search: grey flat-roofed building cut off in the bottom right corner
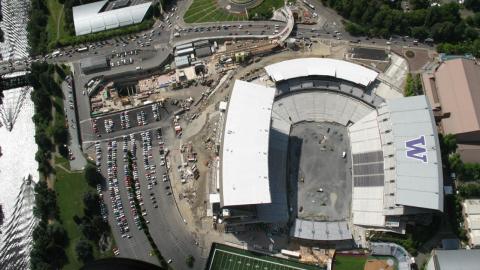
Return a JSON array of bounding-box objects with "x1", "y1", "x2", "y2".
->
[{"x1": 425, "y1": 249, "x2": 480, "y2": 270}]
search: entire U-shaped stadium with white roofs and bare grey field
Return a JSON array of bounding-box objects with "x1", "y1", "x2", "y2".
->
[{"x1": 218, "y1": 58, "x2": 443, "y2": 242}]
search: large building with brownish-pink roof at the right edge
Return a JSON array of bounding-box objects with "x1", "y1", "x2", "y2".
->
[{"x1": 422, "y1": 58, "x2": 480, "y2": 162}]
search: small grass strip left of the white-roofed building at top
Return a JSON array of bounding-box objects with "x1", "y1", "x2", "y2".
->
[{"x1": 46, "y1": 0, "x2": 68, "y2": 44}]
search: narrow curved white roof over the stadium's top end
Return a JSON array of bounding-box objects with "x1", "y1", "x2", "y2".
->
[{"x1": 265, "y1": 58, "x2": 378, "y2": 86}]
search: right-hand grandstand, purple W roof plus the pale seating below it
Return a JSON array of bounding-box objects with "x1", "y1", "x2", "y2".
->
[{"x1": 349, "y1": 96, "x2": 443, "y2": 227}]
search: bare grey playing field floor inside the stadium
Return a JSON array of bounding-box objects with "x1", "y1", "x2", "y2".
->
[{"x1": 289, "y1": 122, "x2": 352, "y2": 221}]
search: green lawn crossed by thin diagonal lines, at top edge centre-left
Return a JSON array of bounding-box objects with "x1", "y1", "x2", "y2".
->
[{"x1": 183, "y1": 0, "x2": 247, "y2": 23}]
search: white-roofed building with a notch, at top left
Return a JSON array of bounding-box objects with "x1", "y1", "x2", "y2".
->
[{"x1": 72, "y1": 0, "x2": 152, "y2": 36}]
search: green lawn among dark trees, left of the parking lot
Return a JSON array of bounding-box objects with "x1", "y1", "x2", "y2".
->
[{"x1": 55, "y1": 163, "x2": 113, "y2": 270}]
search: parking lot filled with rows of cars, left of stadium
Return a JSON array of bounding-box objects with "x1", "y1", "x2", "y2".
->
[{"x1": 95, "y1": 129, "x2": 172, "y2": 262}]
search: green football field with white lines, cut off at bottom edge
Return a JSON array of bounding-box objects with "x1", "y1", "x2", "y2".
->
[{"x1": 208, "y1": 246, "x2": 322, "y2": 270}]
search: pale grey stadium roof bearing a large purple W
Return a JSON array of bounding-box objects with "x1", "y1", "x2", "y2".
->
[{"x1": 378, "y1": 96, "x2": 443, "y2": 211}]
